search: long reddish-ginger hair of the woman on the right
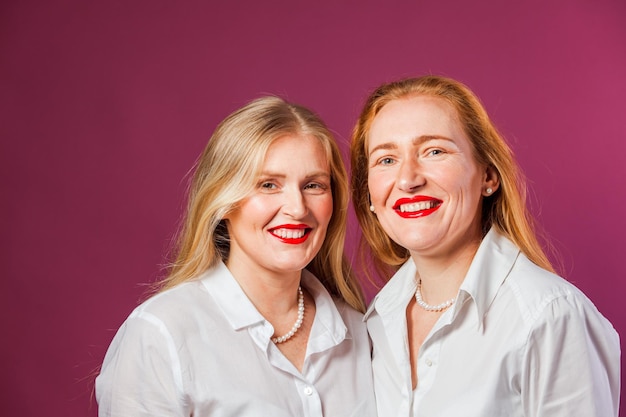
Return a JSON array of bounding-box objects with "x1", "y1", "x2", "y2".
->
[{"x1": 350, "y1": 75, "x2": 554, "y2": 279}]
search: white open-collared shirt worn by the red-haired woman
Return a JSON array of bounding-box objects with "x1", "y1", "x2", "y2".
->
[{"x1": 366, "y1": 230, "x2": 620, "y2": 417}]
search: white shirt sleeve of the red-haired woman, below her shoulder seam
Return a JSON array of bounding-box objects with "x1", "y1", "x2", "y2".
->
[{"x1": 520, "y1": 294, "x2": 620, "y2": 417}]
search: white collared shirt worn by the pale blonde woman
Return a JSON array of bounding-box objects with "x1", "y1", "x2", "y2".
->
[{"x1": 96, "y1": 264, "x2": 376, "y2": 417}]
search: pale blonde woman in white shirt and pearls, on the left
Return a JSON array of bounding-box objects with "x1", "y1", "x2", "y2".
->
[{"x1": 96, "y1": 97, "x2": 376, "y2": 417}]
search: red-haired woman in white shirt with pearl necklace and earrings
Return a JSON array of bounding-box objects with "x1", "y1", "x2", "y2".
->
[{"x1": 351, "y1": 76, "x2": 620, "y2": 417}]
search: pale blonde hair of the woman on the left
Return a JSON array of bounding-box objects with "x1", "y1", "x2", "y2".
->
[{"x1": 157, "y1": 97, "x2": 365, "y2": 312}]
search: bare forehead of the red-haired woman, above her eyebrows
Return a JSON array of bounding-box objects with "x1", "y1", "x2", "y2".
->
[{"x1": 367, "y1": 96, "x2": 465, "y2": 148}]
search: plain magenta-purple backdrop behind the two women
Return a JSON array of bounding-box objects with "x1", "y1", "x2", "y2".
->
[{"x1": 0, "y1": 0, "x2": 626, "y2": 417}]
